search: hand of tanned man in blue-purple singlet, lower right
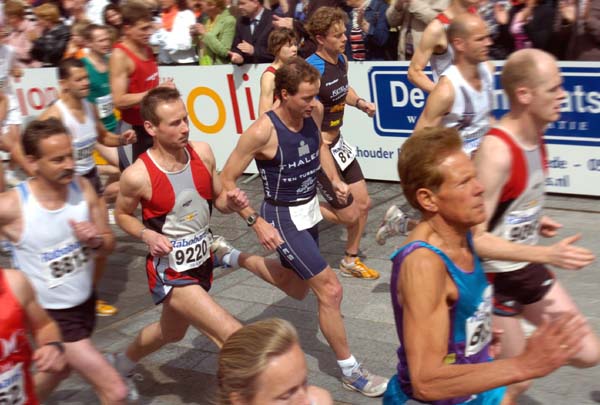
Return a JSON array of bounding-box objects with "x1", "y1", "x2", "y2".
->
[{"x1": 517, "y1": 313, "x2": 587, "y2": 378}]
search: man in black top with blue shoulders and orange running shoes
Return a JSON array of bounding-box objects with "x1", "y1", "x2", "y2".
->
[{"x1": 307, "y1": 7, "x2": 379, "y2": 279}]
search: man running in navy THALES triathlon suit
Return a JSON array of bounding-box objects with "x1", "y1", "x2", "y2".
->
[{"x1": 221, "y1": 58, "x2": 387, "y2": 397}]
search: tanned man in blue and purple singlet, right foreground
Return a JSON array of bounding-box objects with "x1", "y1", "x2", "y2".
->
[{"x1": 383, "y1": 128, "x2": 585, "y2": 405}]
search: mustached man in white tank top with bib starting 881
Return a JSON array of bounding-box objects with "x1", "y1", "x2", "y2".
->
[{"x1": 0, "y1": 118, "x2": 127, "y2": 404}]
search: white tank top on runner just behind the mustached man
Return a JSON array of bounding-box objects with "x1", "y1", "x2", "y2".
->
[{"x1": 56, "y1": 99, "x2": 98, "y2": 176}]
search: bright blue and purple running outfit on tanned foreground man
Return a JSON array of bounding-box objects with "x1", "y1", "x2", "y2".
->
[{"x1": 383, "y1": 234, "x2": 505, "y2": 405}]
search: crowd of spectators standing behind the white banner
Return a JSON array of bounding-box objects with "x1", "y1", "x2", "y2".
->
[{"x1": 0, "y1": 0, "x2": 600, "y2": 68}]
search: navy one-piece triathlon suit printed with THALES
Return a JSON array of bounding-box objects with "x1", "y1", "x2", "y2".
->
[{"x1": 256, "y1": 111, "x2": 327, "y2": 280}]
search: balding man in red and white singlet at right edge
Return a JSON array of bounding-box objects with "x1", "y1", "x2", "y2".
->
[{"x1": 474, "y1": 49, "x2": 600, "y2": 403}]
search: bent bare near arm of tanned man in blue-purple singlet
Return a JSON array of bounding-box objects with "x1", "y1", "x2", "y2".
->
[{"x1": 396, "y1": 249, "x2": 580, "y2": 401}]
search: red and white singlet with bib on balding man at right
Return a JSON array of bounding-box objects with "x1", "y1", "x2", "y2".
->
[{"x1": 484, "y1": 128, "x2": 545, "y2": 273}]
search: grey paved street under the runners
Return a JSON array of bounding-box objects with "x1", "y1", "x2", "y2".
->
[{"x1": 19, "y1": 179, "x2": 600, "y2": 405}]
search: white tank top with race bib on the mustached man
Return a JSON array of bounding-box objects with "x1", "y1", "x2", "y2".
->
[{"x1": 13, "y1": 178, "x2": 94, "y2": 309}]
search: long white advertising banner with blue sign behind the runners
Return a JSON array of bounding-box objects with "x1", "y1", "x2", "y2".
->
[{"x1": 13, "y1": 62, "x2": 600, "y2": 196}]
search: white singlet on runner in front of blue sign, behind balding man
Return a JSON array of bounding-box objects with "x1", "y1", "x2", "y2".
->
[{"x1": 442, "y1": 62, "x2": 494, "y2": 156}]
